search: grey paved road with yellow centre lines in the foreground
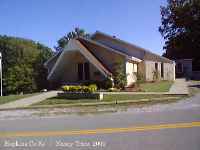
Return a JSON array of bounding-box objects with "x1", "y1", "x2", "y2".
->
[{"x1": 0, "y1": 94, "x2": 200, "y2": 150}]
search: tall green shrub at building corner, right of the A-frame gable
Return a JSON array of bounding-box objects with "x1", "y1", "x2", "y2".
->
[{"x1": 113, "y1": 61, "x2": 127, "y2": 89}]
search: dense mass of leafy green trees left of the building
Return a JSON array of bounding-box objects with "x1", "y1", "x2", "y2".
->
[{"x1": 0, "y1": 36, "x2": 53, "y2": 95}]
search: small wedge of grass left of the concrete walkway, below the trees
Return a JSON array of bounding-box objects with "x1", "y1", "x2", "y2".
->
[{"x1": 0, "y1": 93, "x2": 37, "y2": 105}]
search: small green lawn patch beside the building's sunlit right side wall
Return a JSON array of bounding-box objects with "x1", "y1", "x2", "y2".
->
[{"x1": 140, "y1": 81, "x2": 173, "y2": 92}]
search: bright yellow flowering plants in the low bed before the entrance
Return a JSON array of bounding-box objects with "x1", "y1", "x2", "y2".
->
[{"x1": 62, "y1": 84, "x2": 97, "y2": 93}]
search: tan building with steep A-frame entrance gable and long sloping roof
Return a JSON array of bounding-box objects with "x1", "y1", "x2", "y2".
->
[{"x1": 44, "y1": 31, "x2": 175, "y2": 86}]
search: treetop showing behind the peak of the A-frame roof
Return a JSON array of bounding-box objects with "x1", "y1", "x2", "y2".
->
[{"x1": 55, "y1": 27, "x2": 90, "y2": 51}]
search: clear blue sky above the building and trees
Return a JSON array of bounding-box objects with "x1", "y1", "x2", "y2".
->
[{"x1": 0, "y1": 0, "x2": 166, "y2": 54}]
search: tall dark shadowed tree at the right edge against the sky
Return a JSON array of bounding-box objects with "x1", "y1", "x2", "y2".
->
[{"x1": 159, "y1": 0, "x2": 200, "y2": 69}]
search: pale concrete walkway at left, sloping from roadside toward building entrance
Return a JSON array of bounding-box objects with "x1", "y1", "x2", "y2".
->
[{"x1": 0, "y1": 91, "x2": 58, "y2": 109}]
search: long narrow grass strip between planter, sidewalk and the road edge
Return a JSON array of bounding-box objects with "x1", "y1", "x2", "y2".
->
[{"x1": 33, "y1": 94, "x2": 183, "y2": 106}]
